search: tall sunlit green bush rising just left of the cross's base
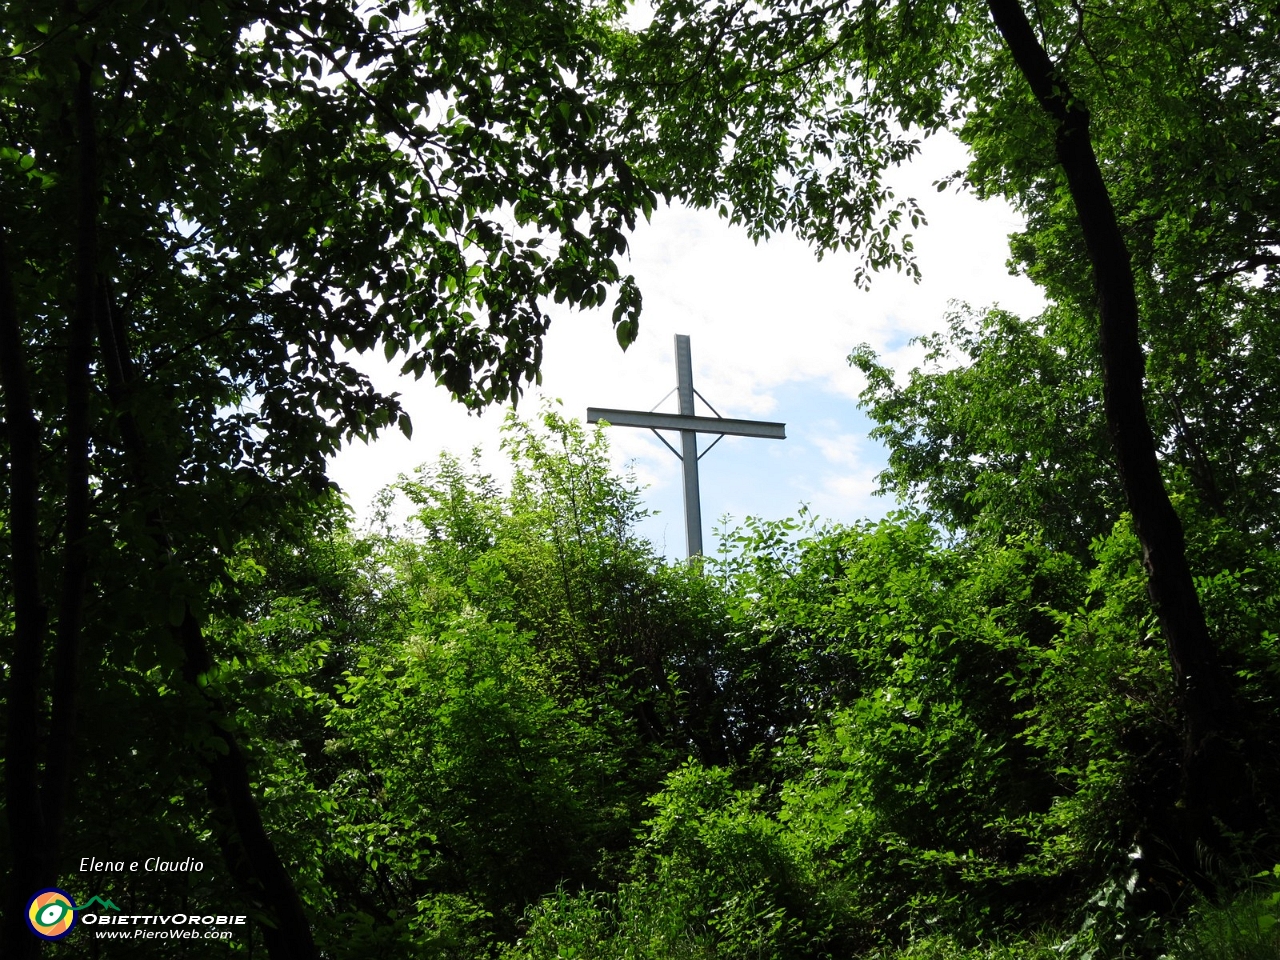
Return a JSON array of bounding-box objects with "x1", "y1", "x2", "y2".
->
[{"x1": 202, "y1": 412, "x2": 759, "y2": 960}]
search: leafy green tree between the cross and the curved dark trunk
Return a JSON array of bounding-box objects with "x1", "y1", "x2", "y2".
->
[{"x1": 850, "y1": 310, "x2": 1123, "y2": 559}]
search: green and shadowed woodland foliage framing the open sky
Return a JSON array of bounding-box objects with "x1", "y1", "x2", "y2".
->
[{"x1": 0, "y1": 0, "x2": 1280, "y2": 960}]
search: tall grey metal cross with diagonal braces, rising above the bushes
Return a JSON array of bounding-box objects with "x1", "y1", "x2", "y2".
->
[{"x1": 586, "y1": 333, "x2": 787, "y2": 558}]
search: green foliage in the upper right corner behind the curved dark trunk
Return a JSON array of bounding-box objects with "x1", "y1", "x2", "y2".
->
[{"x1": 961, "y1": 5, "x2": 1276, "y2": 542}]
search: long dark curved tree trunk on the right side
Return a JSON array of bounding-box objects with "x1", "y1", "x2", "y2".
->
[{"x1": 987, "y1": 0, "x2": 1247, "y2": 874}]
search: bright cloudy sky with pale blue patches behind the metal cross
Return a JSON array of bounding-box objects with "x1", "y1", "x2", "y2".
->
[{"x1": 329, "y1": 136, "x2": 1043, "y2": 559}]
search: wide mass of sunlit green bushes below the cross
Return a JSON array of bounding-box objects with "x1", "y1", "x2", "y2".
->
[{"x1": 30, "y1": 413, "x2": 1280, "y2": 960}]
